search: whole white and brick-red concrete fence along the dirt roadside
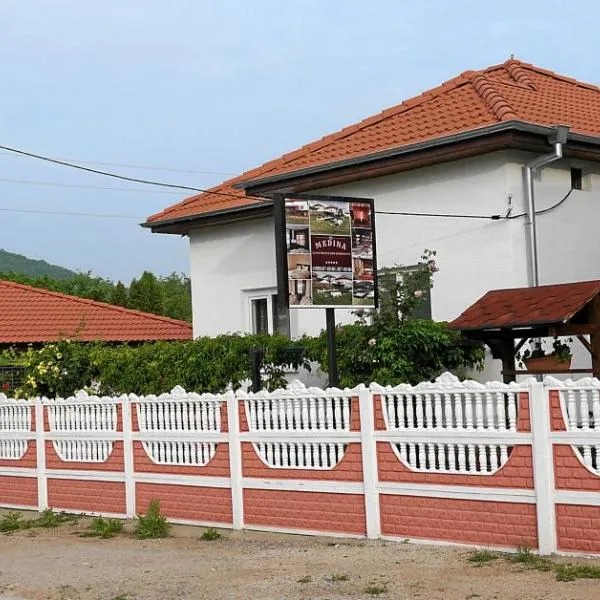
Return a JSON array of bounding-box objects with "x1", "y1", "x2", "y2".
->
[{"x1": 0, "y1": 374, "x2": 600, "y2": 554}]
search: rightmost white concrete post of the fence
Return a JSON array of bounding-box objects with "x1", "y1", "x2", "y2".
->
[{"x1": 529, "y1": 381, "x2": 556, "y2": 555}]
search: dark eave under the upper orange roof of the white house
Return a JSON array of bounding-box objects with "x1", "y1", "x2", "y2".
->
[{"x1": 233, "y1": 120, "x2": 600, "y2": 195}]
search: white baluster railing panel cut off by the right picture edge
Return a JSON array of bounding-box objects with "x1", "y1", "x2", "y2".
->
[{"x1": 544, "y1": 377, "x2": 600, "y2": 475}]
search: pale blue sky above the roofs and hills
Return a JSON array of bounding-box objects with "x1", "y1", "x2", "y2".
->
[{"x1": 0, "y1": 0, "x2": 600, "y2": 281}]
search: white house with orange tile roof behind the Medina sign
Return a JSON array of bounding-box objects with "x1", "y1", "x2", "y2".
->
[{"x1": 144, "y1": 59, "x2": 600, "y2": 376}]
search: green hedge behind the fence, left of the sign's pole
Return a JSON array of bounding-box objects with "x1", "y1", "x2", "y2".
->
[{"x1": 10, "y1": 335, "x2": 308, "y2": 397}]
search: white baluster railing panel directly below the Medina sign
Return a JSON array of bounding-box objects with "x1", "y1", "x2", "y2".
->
[{"x1": 237, "y1": 381, "x2": 358, "y2": 469}]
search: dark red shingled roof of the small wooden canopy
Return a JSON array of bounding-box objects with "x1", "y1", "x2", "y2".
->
[{"x1": 450, "y1": 281, "x2": 600, "y2": 331}]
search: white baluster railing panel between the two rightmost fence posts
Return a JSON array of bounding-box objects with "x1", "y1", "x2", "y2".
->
[{"x1": 370, "y1": 373, "x2": 527, "y2": 475}]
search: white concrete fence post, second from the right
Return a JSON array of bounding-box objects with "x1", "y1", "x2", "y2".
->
[{"x1": 358, "y1": 387, "x2": 381, "y2": 540}]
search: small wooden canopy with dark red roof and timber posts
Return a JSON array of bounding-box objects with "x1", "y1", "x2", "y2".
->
[{"x1": 449, "y1": 281, "x2": 600, "y2": 382}]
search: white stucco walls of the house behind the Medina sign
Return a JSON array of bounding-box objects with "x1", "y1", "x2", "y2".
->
[{"x1": 190, "y1": 152, "x2": 600, "y2": 378}]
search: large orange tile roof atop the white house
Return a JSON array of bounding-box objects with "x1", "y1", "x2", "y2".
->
[{"x1": 147, "y1": 59, "x2": 600, "y2": 224}]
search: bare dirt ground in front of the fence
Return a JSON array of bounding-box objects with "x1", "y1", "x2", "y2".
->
[{"x1": 0, "y1": 520, "x2": 600, "y2": 600}]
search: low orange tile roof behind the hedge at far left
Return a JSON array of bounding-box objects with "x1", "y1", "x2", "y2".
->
[{"x1": 0, "y1": 280, "x2": 192, "y2": 344}]
